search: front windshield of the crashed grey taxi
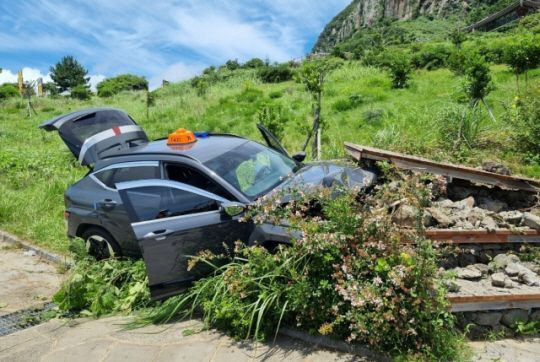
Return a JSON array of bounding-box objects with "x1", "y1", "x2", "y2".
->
[{"x1": 204, "y1": 142, "x2": 296, "y2": 200}]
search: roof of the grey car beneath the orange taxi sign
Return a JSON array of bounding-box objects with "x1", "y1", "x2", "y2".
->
[{"x1": 95, "y1": 134, "x2": 251, "y2": 170}]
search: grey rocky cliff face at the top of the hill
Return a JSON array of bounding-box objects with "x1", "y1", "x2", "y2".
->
[{"x1": 313, "y1": 0, "x2": 506, "y2": 52}]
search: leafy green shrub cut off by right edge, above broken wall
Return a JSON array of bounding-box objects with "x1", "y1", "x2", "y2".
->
[{"x1": 510, "y1": 89, "x2": 540, "y2": 164}]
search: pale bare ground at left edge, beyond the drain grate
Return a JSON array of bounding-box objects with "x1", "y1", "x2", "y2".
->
[{"x1": 0, "y1": 241, "x2": 63, "y2": 316}]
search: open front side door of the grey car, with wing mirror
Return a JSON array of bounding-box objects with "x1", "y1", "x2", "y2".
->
[{"x1": 116, "y1": 180, "x2": 251, "y2": 299}]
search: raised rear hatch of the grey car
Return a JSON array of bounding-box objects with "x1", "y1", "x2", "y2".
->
[{"x1": 39, "y1": 108, "x2": 148, "y2": 165}]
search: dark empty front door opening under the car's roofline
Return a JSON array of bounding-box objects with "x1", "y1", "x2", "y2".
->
[{"x1": 165, "y1": 163, "x2": 237, "y2": 201}]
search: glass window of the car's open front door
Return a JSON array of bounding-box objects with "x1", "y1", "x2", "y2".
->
[{"x1": 122, "y1": 186, "x2": 219, "y2": 222}]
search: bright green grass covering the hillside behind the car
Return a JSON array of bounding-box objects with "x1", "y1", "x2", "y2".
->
[{"x1": 0, "y1": 13, "x2": 540, "y2": 252}]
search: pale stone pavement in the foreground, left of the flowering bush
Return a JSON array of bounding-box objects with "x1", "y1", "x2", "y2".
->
[{"x1": 0, "y1": 317, "x2": 366, "y2": 362}]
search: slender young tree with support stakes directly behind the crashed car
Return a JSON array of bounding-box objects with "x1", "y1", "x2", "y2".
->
[{"x1": 298, "y1": 58, "x2": 341, "y2": 158}]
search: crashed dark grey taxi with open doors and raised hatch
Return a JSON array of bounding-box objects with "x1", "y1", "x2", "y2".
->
[{"x1": 39, "y1": 108, "x2": 376, "y2": 299}]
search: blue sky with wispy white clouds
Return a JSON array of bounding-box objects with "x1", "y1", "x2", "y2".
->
[{"x1": 0, "y1": 0, "x2": 350, "y2": 89}]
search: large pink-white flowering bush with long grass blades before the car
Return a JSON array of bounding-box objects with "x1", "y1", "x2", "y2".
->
[{"x1": 138, "y1": 179, "x2": 459, "y2": 360}]
